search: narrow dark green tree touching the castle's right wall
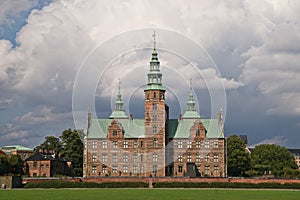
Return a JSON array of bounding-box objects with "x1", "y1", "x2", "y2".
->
[{"x1": 227, "y1": 135, "x2": 250, "y2": 176}]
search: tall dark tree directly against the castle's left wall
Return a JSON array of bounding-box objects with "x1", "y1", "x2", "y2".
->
[{"x1": 60, "y1": 129, "x2": 83, "y2": 176}]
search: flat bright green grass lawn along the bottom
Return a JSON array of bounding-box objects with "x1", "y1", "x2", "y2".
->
[{"x1": 0, "y1": 189, "x2": 300, "y2": 200}]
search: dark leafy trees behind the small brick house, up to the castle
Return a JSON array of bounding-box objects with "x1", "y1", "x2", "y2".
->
[{"x1": 34, "y1": 129, "x2": 83, "y2": 176}]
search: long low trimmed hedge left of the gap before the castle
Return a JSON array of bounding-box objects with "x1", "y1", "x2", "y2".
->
[{"x1": 24, "y1": 181, "x2": 148, "y2": 188}]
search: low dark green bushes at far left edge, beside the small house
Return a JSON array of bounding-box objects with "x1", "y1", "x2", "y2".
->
[{"x1": 0, "y1": 155, "x2": 24, "y2": 175}]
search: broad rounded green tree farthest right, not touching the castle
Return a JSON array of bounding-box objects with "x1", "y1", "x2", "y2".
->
[{"x1": 251, "y1": 144, "x2": 298, "y2": 177}]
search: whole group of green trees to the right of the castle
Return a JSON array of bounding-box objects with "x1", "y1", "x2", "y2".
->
[{"x1": 227, "y1": 135, "x2": 300, "y2": 178}]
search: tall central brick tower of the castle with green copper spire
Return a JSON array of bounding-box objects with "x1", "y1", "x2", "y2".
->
[{"x1": 144, "y1": 32, "x2": 169, "y2": 176}]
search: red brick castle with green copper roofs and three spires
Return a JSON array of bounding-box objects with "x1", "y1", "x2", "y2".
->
[{"x1": 83, "y1": 35, "x2": 227, "y2": 177}]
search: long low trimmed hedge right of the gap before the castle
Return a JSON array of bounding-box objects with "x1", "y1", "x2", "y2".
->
[{"x1": 153, "y1": 182, "x2": 300, "y2": 189}]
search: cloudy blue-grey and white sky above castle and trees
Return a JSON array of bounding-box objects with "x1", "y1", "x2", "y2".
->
[{"x1": 0, "y1": 0, "x2": 300, "y2": 148}]
